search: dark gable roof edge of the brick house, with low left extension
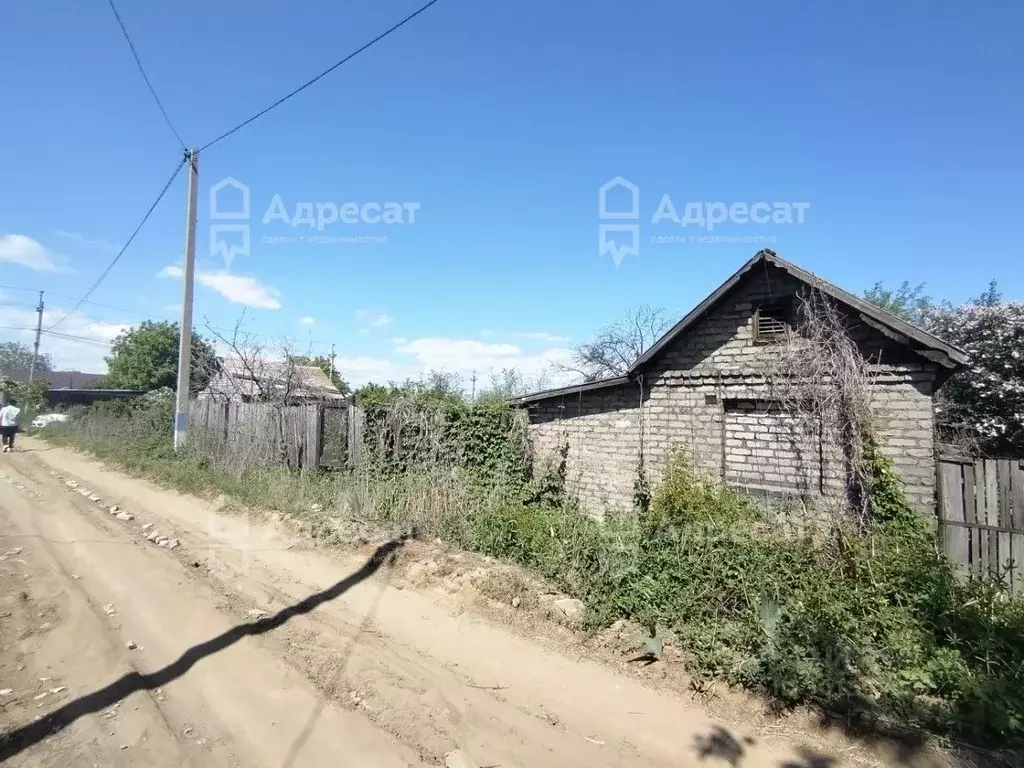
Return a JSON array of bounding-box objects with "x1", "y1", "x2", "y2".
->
[{"x1": 513, "y1": 249, "x2": 968, "y2": 404}]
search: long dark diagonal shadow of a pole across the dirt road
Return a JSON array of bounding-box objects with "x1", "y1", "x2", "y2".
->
[{"x1": 0, "y1": 537, "x2": 408, "y2": 764}]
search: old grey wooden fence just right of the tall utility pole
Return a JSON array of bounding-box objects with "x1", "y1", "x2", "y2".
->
[{"x1": 189, "y1": 398, "x2": 362, "y2": 469}]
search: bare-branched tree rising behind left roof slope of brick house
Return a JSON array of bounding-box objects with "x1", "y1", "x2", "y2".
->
[{"x1": 562, "y1": 304, "x2": 671, "y2": 381}]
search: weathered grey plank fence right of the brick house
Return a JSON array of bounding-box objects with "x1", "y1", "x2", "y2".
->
[{"x1": 937, "y1": 458, "x2": 1024, "y2": 592}]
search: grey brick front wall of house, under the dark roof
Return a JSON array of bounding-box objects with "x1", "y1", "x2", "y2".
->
[{"x1": 528, "y1": 267, "x2": 936, "y2": 516}]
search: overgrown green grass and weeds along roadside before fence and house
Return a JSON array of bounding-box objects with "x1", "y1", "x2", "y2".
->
[{"x1": 47, "y1": 406, "x2": 1024, "y2": 749}]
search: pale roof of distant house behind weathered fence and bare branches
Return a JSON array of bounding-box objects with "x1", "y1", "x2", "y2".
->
[{"x1": 199, "y1": 359, "x2": 345, "y2": 403}]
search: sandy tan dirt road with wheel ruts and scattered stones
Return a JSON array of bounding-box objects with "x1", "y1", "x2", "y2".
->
[{"x1": 0, "y1": 438, "x2": 942, "y2": 768}]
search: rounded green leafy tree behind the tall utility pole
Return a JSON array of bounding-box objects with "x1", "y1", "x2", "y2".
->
[{"x1": 103, "y1": 321, "x2": 218, "y2": 392}]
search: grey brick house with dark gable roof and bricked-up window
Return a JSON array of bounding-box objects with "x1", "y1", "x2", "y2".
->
[{"x1": 515, "y1": 251, "x2": 967, "y2": 516}]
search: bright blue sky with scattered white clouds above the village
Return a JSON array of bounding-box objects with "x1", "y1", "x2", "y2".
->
[{"x1": 0, "y1": 0, "x2": 1024, "y2": 381}]
